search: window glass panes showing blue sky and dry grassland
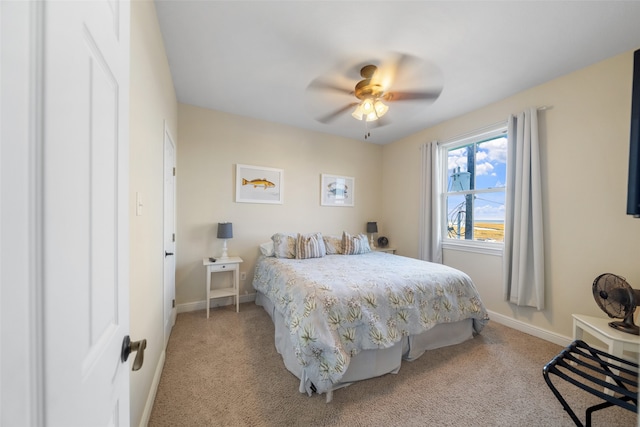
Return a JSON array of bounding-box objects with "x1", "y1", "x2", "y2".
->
[{"x1": 442, "y1": 126, "x2": 507, "y2": 244}]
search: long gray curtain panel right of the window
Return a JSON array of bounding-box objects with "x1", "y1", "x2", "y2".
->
[{"x1": 503, "y1": 108, "x2": 544, "y2": 310}]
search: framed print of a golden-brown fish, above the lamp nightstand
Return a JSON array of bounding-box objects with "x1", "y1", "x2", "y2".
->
[{"x1": 236, "y1": 164, "x2": 284, "y2": 204}]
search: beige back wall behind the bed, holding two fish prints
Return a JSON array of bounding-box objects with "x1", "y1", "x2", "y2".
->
[{"x1": 176, "y1": 104, "x2": 386, "y2": 308}]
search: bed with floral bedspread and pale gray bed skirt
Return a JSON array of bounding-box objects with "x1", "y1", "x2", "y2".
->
[{"x1": 253, "y1": 237, "x2": 489, "y2": 402}]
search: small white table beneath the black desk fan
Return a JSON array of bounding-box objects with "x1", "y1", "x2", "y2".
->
[{"x1": 572, "y1": 314, "x2": 640, "y2": 394}]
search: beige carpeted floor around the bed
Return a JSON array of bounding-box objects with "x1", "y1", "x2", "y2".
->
[{"x1": 149, "y1": 303, "x2": 637, "y2": 427}]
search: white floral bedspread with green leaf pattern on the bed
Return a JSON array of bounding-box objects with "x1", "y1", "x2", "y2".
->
[{"x1": 253, "y1": 252, "x2": 489, "y2": 393}]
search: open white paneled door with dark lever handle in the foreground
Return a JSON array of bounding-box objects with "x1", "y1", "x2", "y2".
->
[{"x1": 42, "y1": 0, "x2": 133, "y2": 426}]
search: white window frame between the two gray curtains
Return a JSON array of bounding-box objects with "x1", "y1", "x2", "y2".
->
[{"x1": 439, "y1": 121, "x2": 509, "y2": 256}]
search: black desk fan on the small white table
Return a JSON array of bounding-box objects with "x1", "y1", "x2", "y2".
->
[{"x1": 592, "y1": 273, "x2": 640, "y2": 335}]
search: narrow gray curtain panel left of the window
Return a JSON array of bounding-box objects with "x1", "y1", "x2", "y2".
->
[{"x1": 418, "y1": 141, "x2": 442, "y2": 264}]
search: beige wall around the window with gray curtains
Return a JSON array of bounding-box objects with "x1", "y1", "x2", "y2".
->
[{"x1": 382, "y1": 47, "x2": 640, "y2": 337}]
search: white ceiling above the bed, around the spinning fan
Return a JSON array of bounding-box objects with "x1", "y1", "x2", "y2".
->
[{"x1": 156, "y1": 0, "x2": 640, "y2": 144}]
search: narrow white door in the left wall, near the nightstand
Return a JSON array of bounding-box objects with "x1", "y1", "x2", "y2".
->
[{"x1": 164, "y1": 124, "x2": 176, "y2": 348}]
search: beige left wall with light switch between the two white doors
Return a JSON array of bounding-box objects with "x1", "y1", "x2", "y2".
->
[{"x1": 129, "y1": 1, "x2": 178, "y2": 426}]
